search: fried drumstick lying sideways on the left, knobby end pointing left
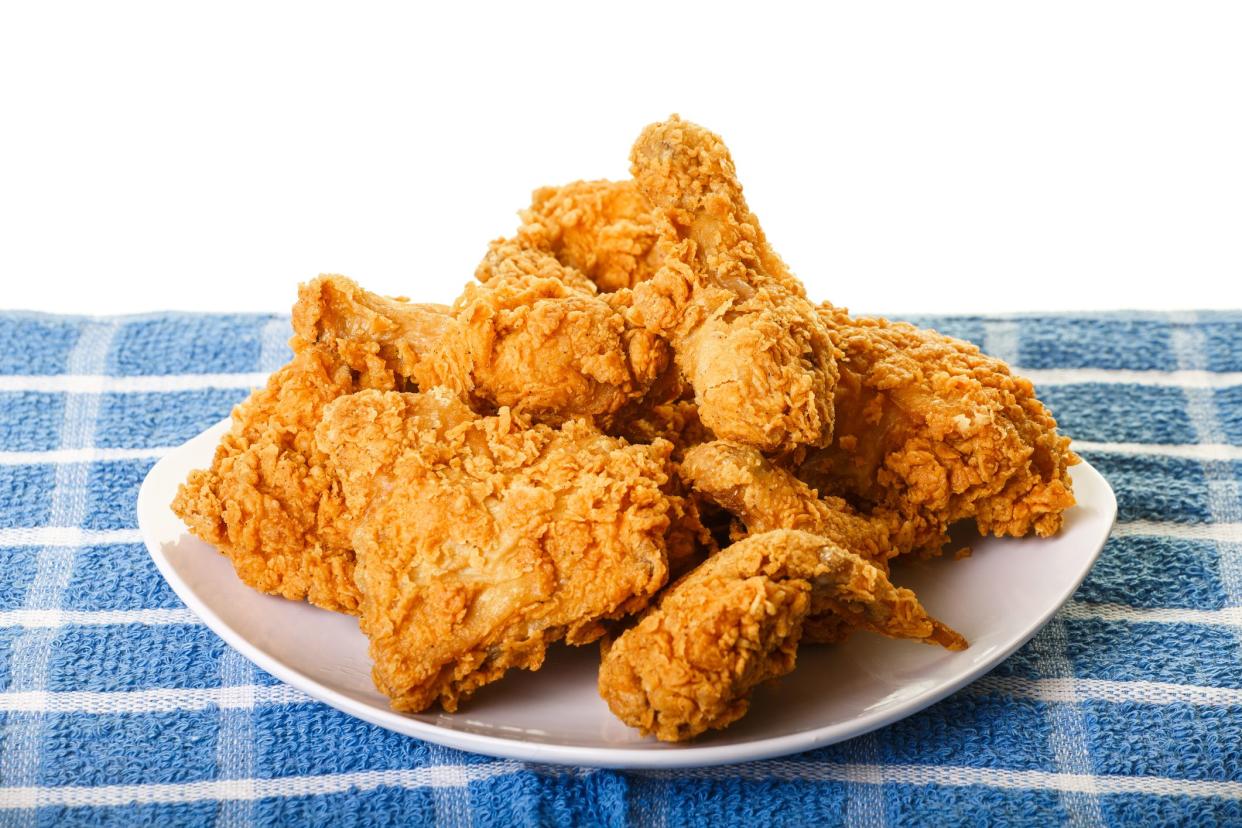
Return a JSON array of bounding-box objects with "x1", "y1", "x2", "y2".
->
[{"x1": 293, "y1": 265, "x2": 671, "y2": 425}]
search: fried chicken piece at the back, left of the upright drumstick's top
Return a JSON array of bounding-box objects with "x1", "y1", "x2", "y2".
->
[{"x1": 476, "y1": 181, "x2": 660, "y2": 292}]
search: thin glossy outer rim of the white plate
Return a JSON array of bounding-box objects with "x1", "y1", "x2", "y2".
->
[{"x1": 137, "y1": 418, "x2": 1117, "y2": 770}]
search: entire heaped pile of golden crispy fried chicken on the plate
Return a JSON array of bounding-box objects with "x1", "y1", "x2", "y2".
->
[{"x1": 173, "y1": 115, "x2": 1078, "y2": 741}]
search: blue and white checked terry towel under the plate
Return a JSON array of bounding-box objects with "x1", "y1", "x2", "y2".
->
[{"x1": 0, "y1": 313, "x2": 1242, "y2": 826}]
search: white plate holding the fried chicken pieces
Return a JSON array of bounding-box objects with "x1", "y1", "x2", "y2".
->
[{"x1": 138, "y1": 422, "x2": 1117, "y2": 767}]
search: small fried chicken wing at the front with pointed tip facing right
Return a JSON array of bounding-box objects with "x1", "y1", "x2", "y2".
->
[{"x1": 599, "y1": 530, "x2": 965, "y2": 741}]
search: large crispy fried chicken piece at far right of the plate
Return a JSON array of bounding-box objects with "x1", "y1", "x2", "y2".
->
[{"x1": 797, "y1": 304, "x2": 1078, "y2": 543}]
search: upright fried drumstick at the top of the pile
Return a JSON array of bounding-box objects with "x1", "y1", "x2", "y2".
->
[{"x1": 630, "y1": 115, "x2": 836, "y2": 451}]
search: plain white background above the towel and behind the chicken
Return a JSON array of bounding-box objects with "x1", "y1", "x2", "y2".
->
[{"x1": 0, "y1": 1, "x2": 1242, "y2": 313}]
